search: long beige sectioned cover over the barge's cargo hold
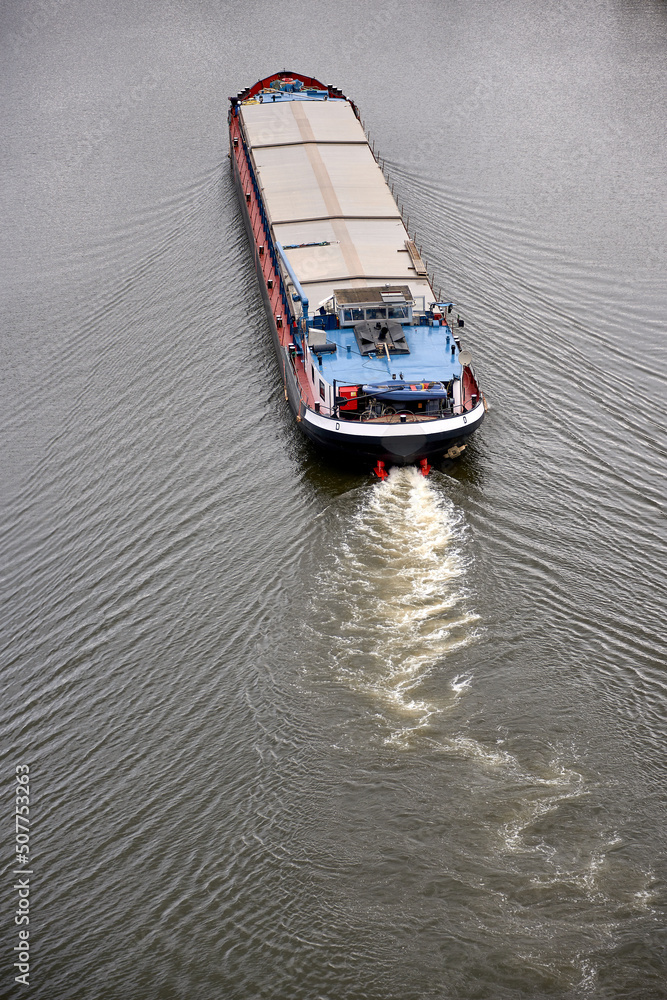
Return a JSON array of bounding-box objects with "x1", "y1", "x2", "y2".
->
[{"x1": 240, "y1": 101, "x2": 432, "y2": 305}]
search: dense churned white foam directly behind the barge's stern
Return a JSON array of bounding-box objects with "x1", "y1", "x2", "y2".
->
[{"x1": 317, "y1": 468, "x2": 477, "y2": 743}]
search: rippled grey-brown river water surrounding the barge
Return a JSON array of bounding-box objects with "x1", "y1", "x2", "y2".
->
[{"x1": 0, "y1": 0, "x2": 667, "y2": 1000}]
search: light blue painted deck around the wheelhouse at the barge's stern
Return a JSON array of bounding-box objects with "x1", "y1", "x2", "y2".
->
[{"x1": 310, "y1": 326, "x2": 462, "y2": 385}]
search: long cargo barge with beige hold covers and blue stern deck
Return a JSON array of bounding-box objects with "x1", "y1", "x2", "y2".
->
[{"x1": 229, "y1": 72, "x2": 486, "y2": 475}]
